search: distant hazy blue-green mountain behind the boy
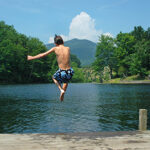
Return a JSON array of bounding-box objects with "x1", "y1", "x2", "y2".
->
[{"x1": 46, "y1": 39, "x2": 96, "y2": 66}]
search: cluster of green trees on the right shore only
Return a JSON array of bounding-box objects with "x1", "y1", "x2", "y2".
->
[{"x1": 92, "y1": 26, "x2": 150, "y2": 82}]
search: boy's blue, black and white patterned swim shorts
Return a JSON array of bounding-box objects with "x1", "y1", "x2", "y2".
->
[{"x1": 53, "y1": 68, "x2": 74, "y2": 83}]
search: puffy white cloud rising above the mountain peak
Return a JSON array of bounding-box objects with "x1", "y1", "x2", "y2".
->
[{"x1": 49, "y1": 12, "x2": 111, "y2": 43}]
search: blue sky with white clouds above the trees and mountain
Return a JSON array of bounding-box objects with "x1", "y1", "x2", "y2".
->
[{"x1": 0, "y1": 0, "x2": 150, "y2": 44}]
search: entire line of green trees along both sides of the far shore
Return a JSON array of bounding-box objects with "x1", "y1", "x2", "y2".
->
[{"x1": 0, "y1": 21, "x2": 150, "y2": 83}]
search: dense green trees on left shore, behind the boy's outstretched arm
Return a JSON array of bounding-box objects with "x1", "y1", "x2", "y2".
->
[{"x1": 0, "y1": 21, "x2": 83, "y2": 83}]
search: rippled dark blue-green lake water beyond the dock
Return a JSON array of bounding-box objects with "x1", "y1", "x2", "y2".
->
[{"x1": 0, "y1": 83, "x2": 150, "y2": 133}]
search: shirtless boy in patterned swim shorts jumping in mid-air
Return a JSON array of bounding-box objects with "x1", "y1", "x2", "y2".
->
[{"x1": 27, "y1": 35, "x2": 74, "y2": 101}]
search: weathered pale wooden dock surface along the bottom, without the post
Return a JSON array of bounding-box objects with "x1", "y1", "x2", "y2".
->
[{"x1": 0, "y1": 131, "x2": 150, "y2": 150}]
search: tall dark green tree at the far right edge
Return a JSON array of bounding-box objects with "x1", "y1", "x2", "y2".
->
[{"x1": 130, "y1": 26, "x2": 150, "y2": 77}]
